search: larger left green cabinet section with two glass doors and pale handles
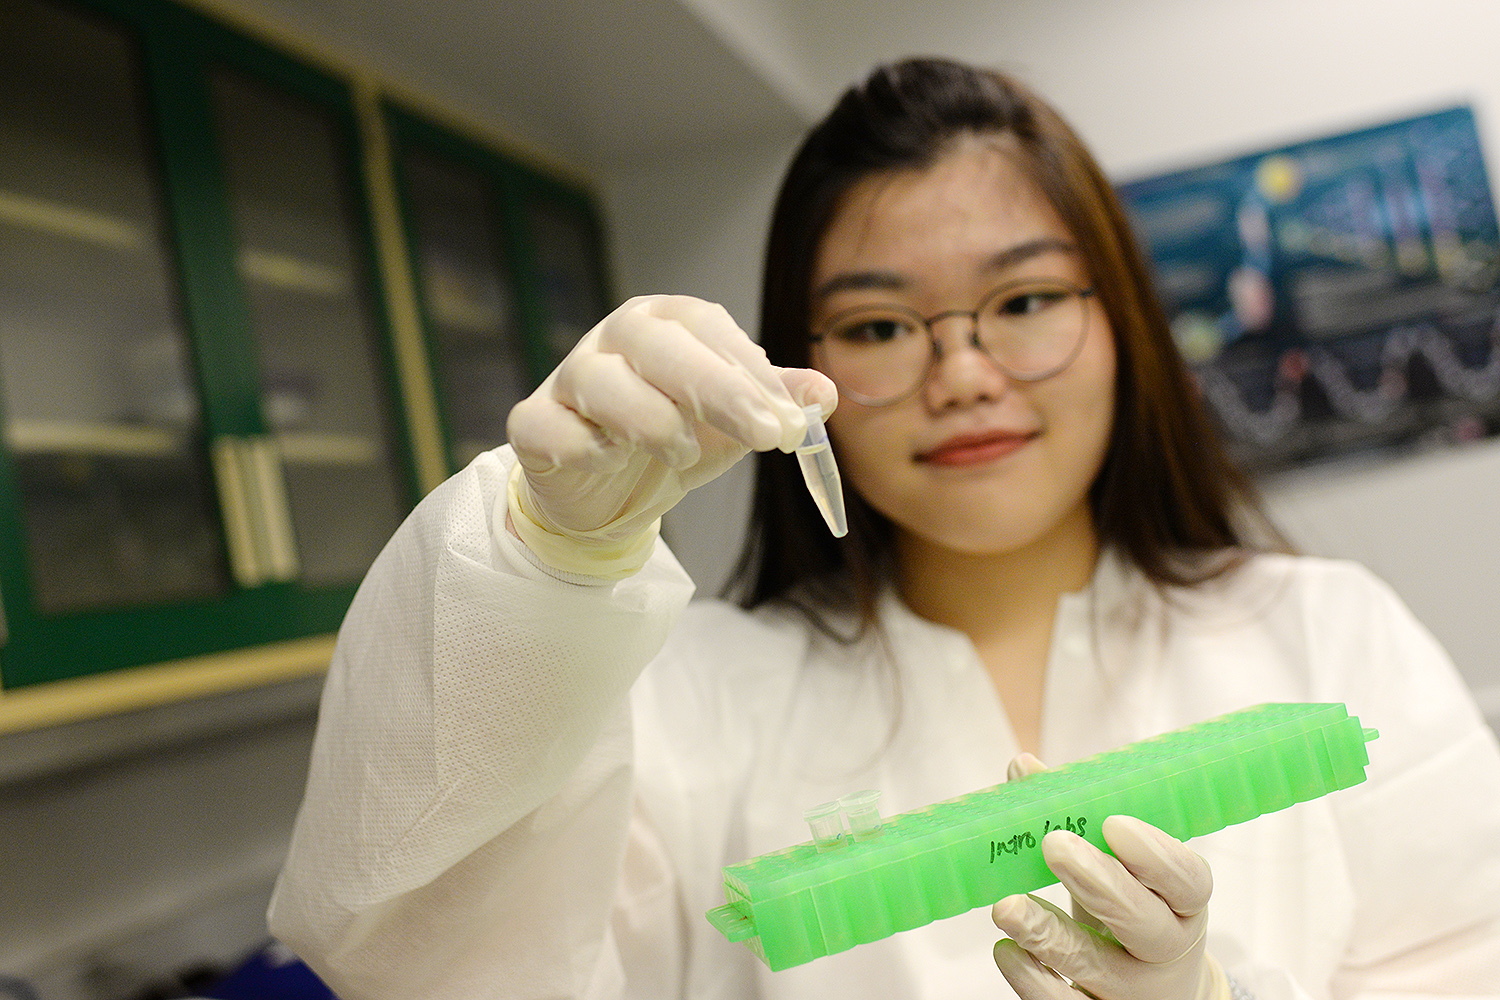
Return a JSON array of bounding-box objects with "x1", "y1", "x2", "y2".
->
[{"x1": 0, "y1": 0, "x2": 417, "y2": 690}]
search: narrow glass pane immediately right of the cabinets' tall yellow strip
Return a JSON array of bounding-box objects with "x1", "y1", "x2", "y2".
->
[{"x1": 401, "y1": 148, "x2": 534, "y2": 466}]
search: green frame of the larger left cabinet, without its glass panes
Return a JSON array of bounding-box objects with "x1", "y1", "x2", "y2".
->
[{"x1": 0, "y1": 0, "x2": 422, "y2": 704}]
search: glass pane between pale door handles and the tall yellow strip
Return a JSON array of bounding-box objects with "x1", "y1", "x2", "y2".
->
[{"x1": 210, "y1": 69, "x2": 405, "y2": 586}]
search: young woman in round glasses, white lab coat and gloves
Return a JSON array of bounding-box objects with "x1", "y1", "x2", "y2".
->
[{"x1": 272, "y1": 60, "x2": 1500, "y2": 1000}]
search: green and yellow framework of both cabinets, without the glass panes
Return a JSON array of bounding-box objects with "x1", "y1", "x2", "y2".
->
[{"x1": 0, "y1": 0, "x2": 614, "y2": 733}]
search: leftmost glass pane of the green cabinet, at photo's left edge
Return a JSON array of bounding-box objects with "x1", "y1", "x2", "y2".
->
[{"x1": 0, "y1": 0, "x2": 231, "y2": 615}]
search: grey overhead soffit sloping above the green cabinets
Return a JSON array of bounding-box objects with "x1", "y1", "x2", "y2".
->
[{"x1": 211, "y1": 0, "x2": 807, "y2": 172}]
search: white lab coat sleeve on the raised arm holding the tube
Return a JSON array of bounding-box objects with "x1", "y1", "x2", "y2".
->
[{"x1": 270, "y1": 448, "x2": 692, "y2": 1000}]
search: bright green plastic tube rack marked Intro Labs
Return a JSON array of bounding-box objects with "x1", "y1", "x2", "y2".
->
[{"x1": 708, "y1": 703, "x2": 1379, "y2": 970}]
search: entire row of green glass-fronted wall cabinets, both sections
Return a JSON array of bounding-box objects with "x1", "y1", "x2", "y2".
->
[{"x1": 0, "y1": 0, "x2": 609, "y2": 730}]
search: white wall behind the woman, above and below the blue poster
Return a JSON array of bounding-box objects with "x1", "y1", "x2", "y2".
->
[{"x1": 612, "y1": 0, "x2": 1500, "y2": 720}]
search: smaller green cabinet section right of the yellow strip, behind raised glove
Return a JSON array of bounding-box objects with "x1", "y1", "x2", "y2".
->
[{"x1": 384, "y1": 103, "x2": 611, "y2": 469}]
